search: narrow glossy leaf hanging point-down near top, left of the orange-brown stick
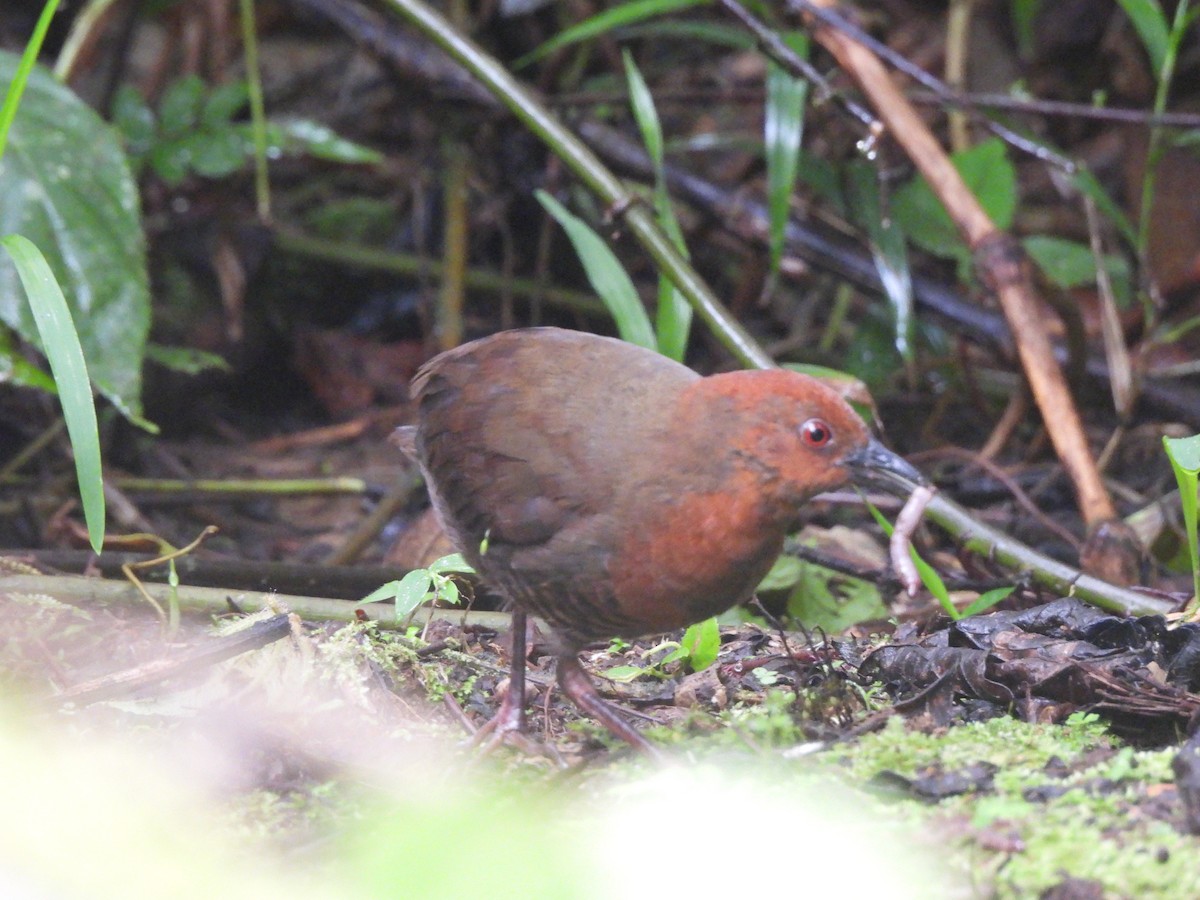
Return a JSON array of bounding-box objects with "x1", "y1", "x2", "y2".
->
[{"x1": 763, "y1": 31, "x2": 809, "y2": 276}]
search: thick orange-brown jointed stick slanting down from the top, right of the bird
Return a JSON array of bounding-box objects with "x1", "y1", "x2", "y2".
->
[{"x1": 796, "y1": 0, "x2": 1116, "y2": 526}]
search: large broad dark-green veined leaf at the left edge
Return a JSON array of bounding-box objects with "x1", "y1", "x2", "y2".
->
[{"x1": 0, "y1": 53, "x2": 150, "y2": 425}]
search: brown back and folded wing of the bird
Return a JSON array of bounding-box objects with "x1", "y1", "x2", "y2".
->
[{"x1": 413, "y1": 329, "x2": 698, "y2": 547}]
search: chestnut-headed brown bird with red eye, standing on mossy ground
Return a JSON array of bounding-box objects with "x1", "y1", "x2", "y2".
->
[{"x1": 395, "y1": 328, "x2": 924, "y2": 755}]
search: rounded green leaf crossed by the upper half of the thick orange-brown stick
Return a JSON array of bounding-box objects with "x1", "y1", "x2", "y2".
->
[{"x1": 892, "y1": 138, "x2": 1016, "y2": 266}]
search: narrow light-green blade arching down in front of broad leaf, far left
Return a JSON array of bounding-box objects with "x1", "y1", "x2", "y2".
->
[{"x1": 0, "y1": 234, "x2": 104, "y2": 553}]
